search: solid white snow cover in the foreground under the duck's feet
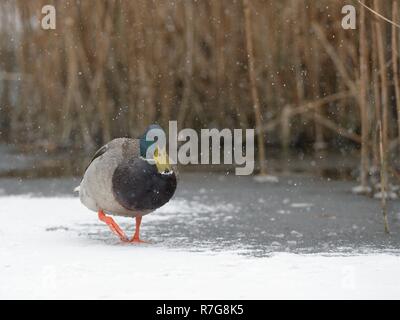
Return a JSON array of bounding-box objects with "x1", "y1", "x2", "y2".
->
[{"x1": 0, "y1": 197, "x2": 400, "y2": 299}]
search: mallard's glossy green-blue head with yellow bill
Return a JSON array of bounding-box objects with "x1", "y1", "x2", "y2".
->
[{"x1": 140, "y1": 124, "x2": 171, "y2": 173}]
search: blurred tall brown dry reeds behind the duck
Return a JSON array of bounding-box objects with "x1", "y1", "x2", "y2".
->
[{"x1": 0, "y1": 0, "x2": 400, "y2": 185}]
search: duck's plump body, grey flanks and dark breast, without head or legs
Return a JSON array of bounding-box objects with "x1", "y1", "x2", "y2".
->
[{"x1": 79, "y1": 138, "x2": 176, "y2": 217}]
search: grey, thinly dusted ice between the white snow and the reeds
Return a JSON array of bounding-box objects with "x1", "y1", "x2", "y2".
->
[{"x1": 0, "y1": 173, "x2": 400, "y2": 256}]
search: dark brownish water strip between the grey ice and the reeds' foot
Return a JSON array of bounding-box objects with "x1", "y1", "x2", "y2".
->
[{"x1": 0, "y1": 144, "x2": 359, "y2": 180}]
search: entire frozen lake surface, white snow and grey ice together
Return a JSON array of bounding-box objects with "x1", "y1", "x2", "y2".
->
[{"x1": 0, "y1": 173, "x2": 400, "y2": 299}]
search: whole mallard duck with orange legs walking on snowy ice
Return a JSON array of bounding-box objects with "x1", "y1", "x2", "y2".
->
[{"x1": 78, "y1": 125, "x2": 177, "y2": 243}]
